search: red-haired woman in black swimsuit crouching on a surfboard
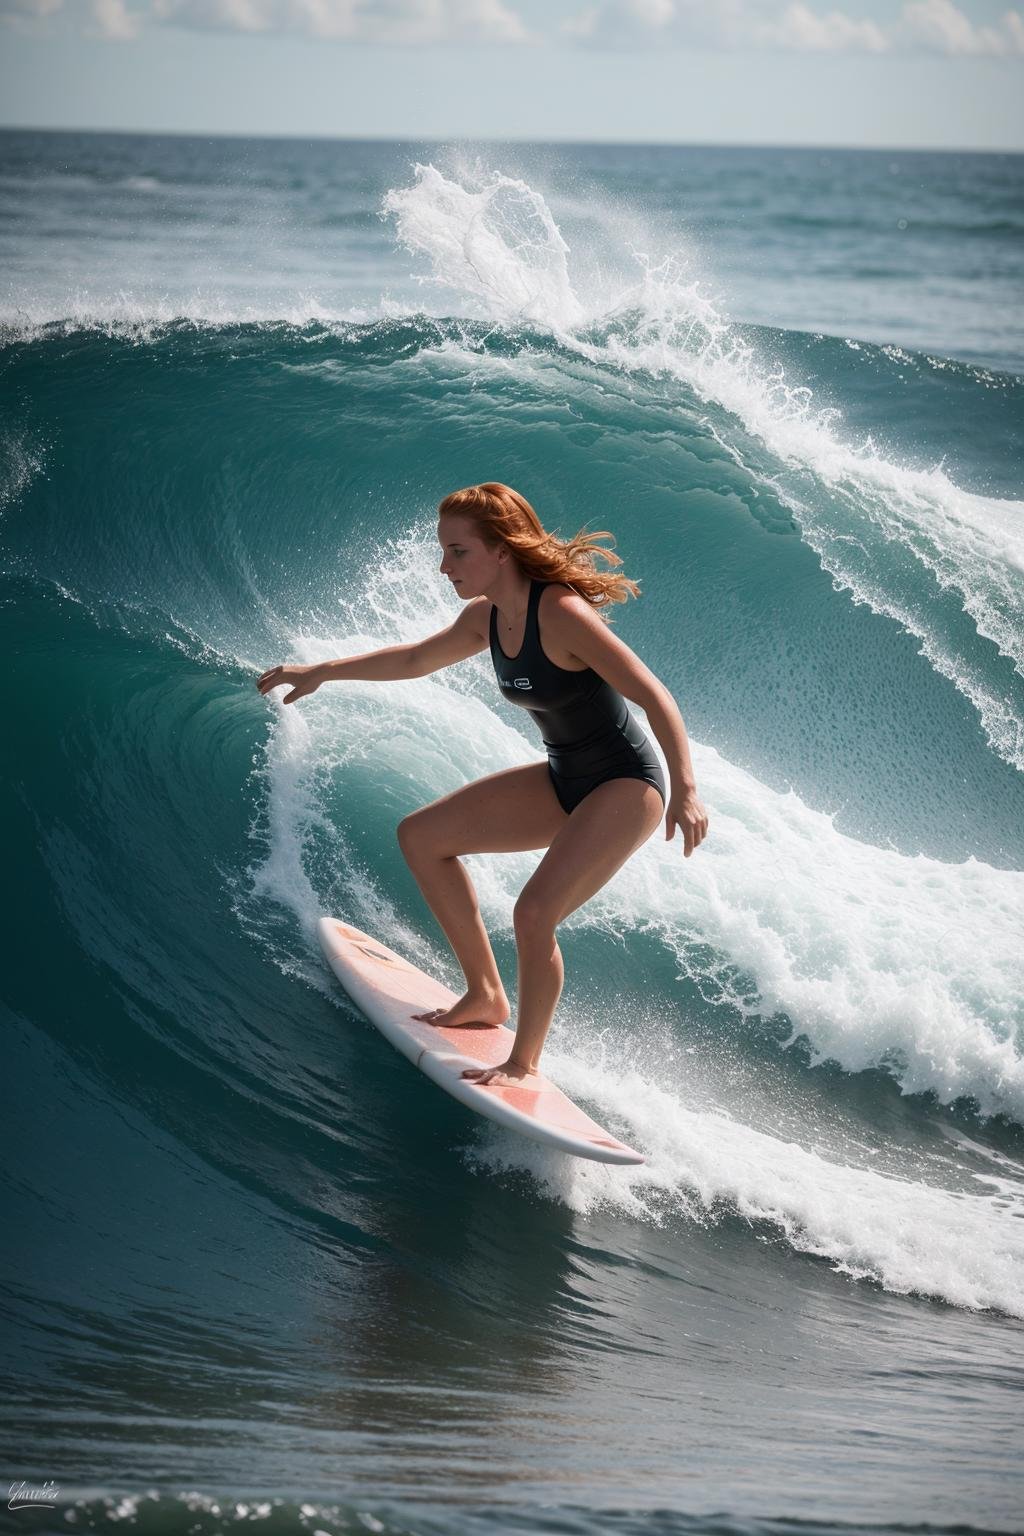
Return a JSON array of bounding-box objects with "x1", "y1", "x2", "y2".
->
[{"x1": 256, "y1": 481, "x2": 708, "y2": 1084}]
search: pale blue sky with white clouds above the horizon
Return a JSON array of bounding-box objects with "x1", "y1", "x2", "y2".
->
[{"x1": 0, "y1": 0, "x2": 1024, "y2": 151}]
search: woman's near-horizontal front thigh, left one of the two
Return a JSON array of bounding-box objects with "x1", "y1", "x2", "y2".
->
[{"x1": 398, "y1": 762, "x2": 568, "y2": 859}]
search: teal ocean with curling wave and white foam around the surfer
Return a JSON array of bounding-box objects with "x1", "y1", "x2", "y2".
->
[{"x1": 0, "y1": 131, "x2": 1024, "y2": 1536}]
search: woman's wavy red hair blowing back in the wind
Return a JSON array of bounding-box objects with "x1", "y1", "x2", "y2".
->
[{"x1": 438, "y1": 481, "x2": 640, "y2": 608}]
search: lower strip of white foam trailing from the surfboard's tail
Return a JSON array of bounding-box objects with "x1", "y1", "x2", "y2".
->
[{"x1": 471, "y1": 1052, "x2": 1024, "y2": 1318}]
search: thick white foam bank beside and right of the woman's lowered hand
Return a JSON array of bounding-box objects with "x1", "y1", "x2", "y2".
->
[{"x1": 617, "y1": 746, "x2": 1024, "y2": 1118}]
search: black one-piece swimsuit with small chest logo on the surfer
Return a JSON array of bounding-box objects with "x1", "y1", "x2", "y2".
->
[{"x1": 491, "y1": 581, "x2": 666, "y2": 814}]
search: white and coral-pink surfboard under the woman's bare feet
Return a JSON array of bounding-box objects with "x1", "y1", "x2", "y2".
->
[{"x1": 318, "y1": 917, "x2": 645, "y2": 1163}]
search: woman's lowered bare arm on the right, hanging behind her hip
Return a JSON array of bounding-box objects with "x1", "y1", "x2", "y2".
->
[{"x1": 545, "y1": 590, "x2": 708, "y2": 859}]
